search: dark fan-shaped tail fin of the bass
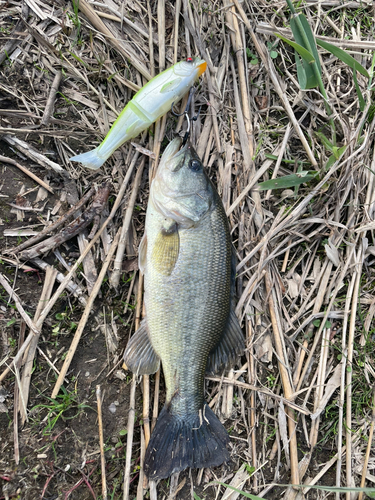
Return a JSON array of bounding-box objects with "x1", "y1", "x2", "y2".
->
[{"x1": 144, "y1": 403, "x2": 229, "y2": 481}]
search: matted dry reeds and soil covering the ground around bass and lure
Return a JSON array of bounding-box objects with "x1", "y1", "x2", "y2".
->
[{"x1": 0, "y1": 0, "x2": 375, "y2": 500}]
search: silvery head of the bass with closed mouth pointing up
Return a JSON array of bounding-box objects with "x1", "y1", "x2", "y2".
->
[{"x1": 151, "y1": 138, "x2": 213, "y2": 228}]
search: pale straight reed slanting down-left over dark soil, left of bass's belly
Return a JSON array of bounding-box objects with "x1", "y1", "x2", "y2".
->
[{"x1": 51, "y1": 230, "x2": 120, "y2": 399}]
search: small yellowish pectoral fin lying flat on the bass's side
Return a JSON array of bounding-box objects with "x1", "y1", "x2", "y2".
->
[{"x1": 151, "y1": 223, "x2": 180, "y2": 276}]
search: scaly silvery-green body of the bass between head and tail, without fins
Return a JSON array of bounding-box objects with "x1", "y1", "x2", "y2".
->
[{"x1": 145, "y1": 186, "x2": 231, "y2": 415}]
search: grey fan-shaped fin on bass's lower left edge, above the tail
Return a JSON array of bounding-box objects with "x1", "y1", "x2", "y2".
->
[{"x1": 124, "y1": 319, "x2": 160, "y2": 375}]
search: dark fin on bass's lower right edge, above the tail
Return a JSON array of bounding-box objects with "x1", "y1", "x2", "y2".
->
[{"x1": 206, "y1": 308, "x2": 245, "y2": 373}]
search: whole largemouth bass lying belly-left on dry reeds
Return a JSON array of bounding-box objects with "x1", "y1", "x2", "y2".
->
[{"x1": 124, "y1": 138, "x2": 244, "y2": 480}]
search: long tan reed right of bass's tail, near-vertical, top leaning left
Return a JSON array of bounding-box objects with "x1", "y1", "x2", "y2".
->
[{"x1": 264, "y1": 273, "x2": 299, "y2": 490}]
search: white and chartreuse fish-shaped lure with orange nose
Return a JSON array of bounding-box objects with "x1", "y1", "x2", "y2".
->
[{"x1": 70, "y1": 57, "x2": 207, "y2": 170}]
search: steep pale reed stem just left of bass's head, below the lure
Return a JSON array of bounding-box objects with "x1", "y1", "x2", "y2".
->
[{"x1": 109, "y1": 153, "x2": 146, "y2": 288}]
